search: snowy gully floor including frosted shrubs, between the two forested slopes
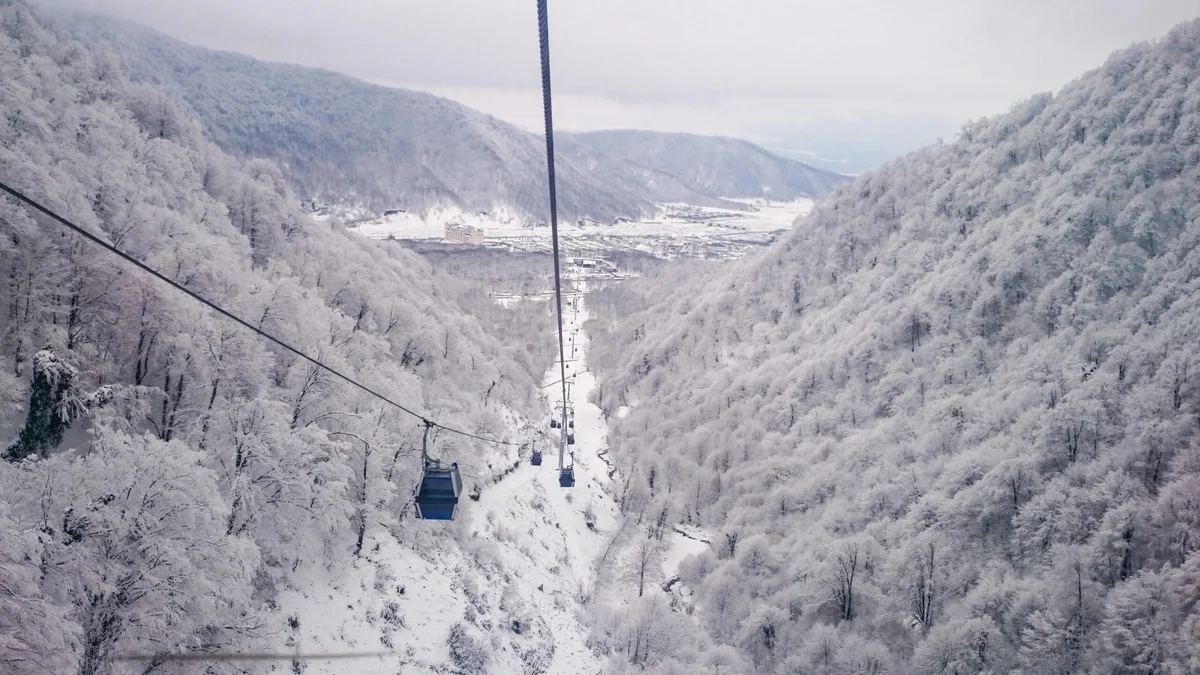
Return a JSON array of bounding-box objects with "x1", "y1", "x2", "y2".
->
[{"x1": 267, "y1": 290, "x2": 729, "y2": 675}]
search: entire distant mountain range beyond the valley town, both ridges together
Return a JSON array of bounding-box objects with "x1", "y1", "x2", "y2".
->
[{"x1": 65, "y1": 16, "x2": 839, "y2": 221}]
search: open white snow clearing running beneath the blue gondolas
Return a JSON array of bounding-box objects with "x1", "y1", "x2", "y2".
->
[{"x1": 276, "y1": 285, "x2": 628, "y2": 675}]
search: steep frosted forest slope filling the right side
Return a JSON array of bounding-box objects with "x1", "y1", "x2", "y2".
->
[{"x1": 588, "y1": 15, "x2": 1200, "y2": 674}]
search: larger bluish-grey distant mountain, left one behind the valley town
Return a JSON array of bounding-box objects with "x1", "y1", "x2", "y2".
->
[{"x1": 58, "y1": 11, "x2": 652, "y2": 221}]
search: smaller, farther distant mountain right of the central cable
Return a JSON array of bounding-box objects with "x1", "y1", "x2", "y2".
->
[{"x1": 569, "y1": 131, "x2": 851, "y2": 201}]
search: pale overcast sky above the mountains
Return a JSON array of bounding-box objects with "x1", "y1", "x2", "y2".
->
[{"x1": 52, "y1": 0, "x2": 1200, "y2": 172}]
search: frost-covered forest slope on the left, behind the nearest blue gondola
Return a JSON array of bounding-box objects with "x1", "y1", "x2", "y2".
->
[{"x1": 0, "y1": 0, "x2": 568, "y2": 674}]
